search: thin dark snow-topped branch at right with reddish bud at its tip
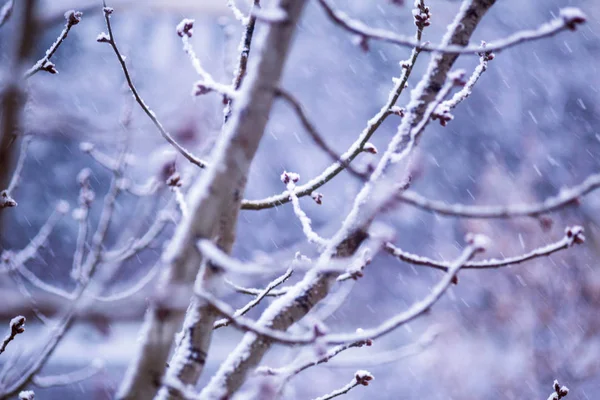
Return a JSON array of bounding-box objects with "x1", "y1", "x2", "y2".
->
[{"x1": 385, "y1": 226, "x2": 585, "y2": 271}]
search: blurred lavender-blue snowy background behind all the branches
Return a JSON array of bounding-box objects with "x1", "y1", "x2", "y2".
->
[{"x1": 0, "y1": 0, "x2": 600, "y2": 400}]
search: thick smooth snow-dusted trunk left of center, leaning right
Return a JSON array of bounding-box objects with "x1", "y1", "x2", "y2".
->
[{"x1": 117, "y1": 0, "x2": 306, "y2": 399}]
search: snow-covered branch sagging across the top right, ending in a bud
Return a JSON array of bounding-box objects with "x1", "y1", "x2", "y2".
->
[{"x1": 317, "y1": 0, "x2": 586, "y2": 54}]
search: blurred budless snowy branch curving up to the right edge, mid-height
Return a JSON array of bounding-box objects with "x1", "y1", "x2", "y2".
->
[{"x1": 396, "y1": 174, "x2": 600, "y2": 218}]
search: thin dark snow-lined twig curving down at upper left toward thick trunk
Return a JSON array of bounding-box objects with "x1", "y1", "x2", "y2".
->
[{"x1": 96, "y1": 2, "x2": 206, "y2": 168}]
